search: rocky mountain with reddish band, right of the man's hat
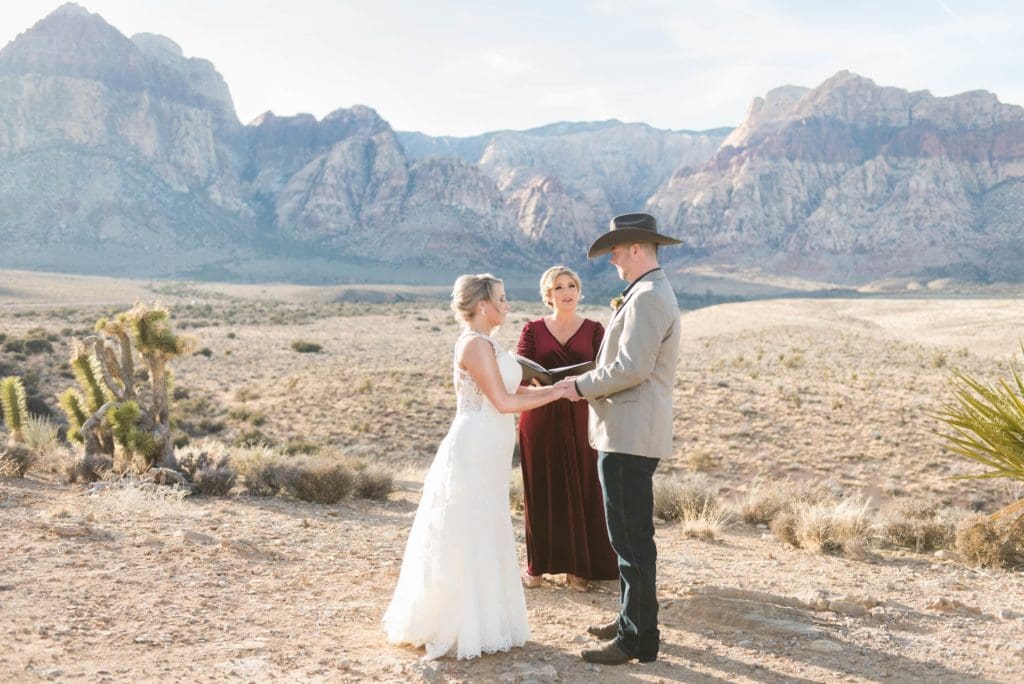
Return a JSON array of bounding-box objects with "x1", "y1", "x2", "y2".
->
[{"x1": 648, "y1": 72, "x2": 1024, "y2": 283}]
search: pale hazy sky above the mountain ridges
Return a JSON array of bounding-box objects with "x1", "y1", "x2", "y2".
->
[{"x1": 0, "y1": 0, "x2": 1024, "y2": 135}]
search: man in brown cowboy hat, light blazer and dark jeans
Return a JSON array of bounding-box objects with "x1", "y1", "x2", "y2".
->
[{"x1": 559, "y1": 214, "x2": 682, "y2": 665}]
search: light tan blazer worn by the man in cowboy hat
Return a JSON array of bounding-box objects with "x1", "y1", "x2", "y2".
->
[{"x1": 577, "y1": 270, "x2": 680, "y2": 459}]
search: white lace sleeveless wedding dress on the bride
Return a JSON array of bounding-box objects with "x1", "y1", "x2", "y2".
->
[{"x1": 383, "y1": 333, "x2": 529, "y2": 659}]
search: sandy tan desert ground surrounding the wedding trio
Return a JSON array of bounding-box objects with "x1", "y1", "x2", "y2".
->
[{"x1": 0, "y1": 271, "x2": 1024, "y2": 682}]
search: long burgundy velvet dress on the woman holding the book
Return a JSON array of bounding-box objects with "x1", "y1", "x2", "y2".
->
[{"x1": 516, "y1": 318, "x2": 618, "y2": 580}]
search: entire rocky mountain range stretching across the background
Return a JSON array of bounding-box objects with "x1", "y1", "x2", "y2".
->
[{"x1": 0, "y1": 4, "x2": 1024, "y2": 285}]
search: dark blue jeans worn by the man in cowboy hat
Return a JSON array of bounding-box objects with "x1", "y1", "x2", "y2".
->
[{"x1": 597, "y1": 452, "x2": 660, "y2": 660}]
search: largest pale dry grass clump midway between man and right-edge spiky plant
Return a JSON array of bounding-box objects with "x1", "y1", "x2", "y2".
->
[{"x1": 770, "y1": 497, "x2": 871, "y2": 556}]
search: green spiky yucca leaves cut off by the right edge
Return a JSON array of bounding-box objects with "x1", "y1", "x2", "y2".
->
[{"x1": 932, "y1": 345, "x2": 1024, "y2": 519}]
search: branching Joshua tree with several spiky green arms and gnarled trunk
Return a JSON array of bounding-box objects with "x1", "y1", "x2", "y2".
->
[{"x1": 60, "y1": 302, "x2": 194, "y2": 468}]
